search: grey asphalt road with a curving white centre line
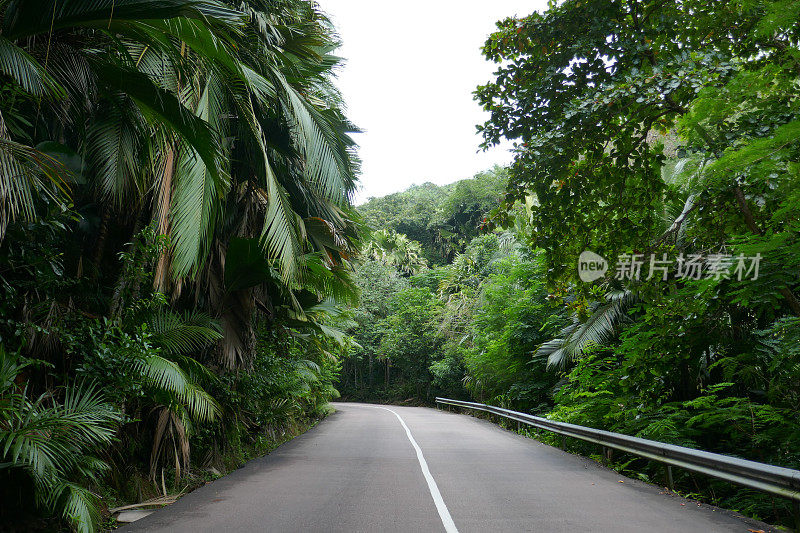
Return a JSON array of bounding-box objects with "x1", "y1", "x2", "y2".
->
[{"x1": 122, "y1": 403, "x2": 770, "y2": 533}]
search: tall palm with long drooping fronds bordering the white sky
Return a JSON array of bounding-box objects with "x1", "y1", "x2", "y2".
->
[{"x1": 179, "y1": 2, "x2": 358, "y2": 367}]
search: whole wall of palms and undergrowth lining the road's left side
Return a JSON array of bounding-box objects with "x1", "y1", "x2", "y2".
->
[{"x1": 0, "y1": 0, "x2": 358, "y2": 531}]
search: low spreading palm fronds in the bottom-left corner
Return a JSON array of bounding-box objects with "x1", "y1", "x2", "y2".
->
[{"x1": 0, "y1": 346, "x2": 122, "y2": 532}]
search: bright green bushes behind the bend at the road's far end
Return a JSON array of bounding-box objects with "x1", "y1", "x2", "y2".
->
[{"x1": 341, "y1": 234, "x2": 560, "y2": 407}]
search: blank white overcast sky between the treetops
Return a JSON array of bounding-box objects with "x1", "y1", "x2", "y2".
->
[{"x1": 318, "y1": 0, "x2": 547, "y2": 203}]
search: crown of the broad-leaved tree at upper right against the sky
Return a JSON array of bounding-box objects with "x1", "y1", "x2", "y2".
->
[{"x1": 476, "y1": 0, "x2": 798, "y2": 296}]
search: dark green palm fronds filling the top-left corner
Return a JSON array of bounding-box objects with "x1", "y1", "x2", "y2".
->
[{"x1": 0, "y1": 0, "x2": 242, "y2": 238}]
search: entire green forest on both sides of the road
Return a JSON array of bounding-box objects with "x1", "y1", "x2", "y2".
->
[{"x1": 0, "y1": 0, "x2": 800, "y2": 531}]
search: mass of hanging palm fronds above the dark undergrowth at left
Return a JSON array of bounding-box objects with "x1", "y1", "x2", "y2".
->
[{"x1": 0, "y1": 0, "x2": 357, "y2": 366}]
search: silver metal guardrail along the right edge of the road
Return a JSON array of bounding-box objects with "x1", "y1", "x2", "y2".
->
[{"x1": 436, "y1": 398, "x2": 800, "y2": 508}]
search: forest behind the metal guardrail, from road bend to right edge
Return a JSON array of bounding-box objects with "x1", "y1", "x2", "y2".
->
[{"x1": 339, "y1": 0, "x2": 800, "y2": 524}]
